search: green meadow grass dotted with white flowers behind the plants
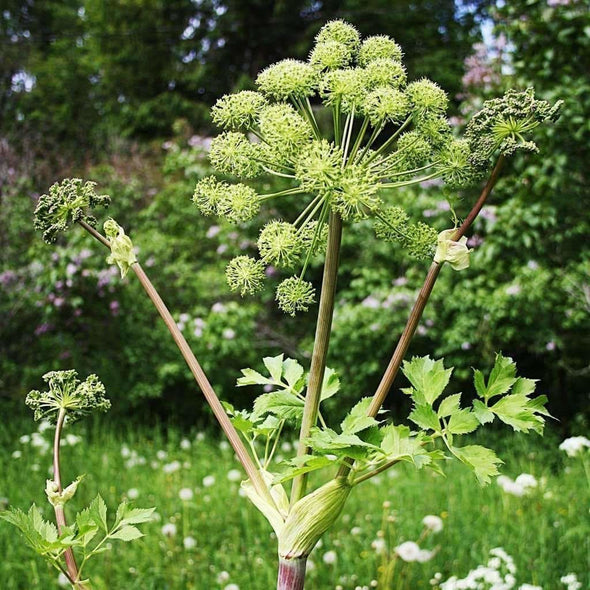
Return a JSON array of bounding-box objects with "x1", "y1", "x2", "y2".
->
[{"x1": 0, "y1": 419, "x2": 590, "y2": 590}]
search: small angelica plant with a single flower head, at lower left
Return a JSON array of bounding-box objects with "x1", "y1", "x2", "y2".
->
[{"x1": 0, "y1": 372, "x2": 154, "y2": 590}]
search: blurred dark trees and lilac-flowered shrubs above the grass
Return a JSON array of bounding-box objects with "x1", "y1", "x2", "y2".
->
[{"x1": 0, "y1": 0, "x2": 590, "y2": 435}]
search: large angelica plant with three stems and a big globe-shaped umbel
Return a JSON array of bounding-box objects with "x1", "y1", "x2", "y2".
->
[{"x1": 26, "y1": 21, "x2": 560, "y2": 590}]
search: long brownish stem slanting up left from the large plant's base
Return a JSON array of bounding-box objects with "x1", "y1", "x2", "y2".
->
[{"x1": 79, "y1": 221, "x2": 275, "y2": 506}]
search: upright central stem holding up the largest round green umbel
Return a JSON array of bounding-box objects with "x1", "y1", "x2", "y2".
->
[{"x1": 291, "y1": 213, "x2": 342, "y2": 506}]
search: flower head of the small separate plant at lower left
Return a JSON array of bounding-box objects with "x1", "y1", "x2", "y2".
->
[{"x1": 25, "y1": 369, "x2": 111, "y2": 423}]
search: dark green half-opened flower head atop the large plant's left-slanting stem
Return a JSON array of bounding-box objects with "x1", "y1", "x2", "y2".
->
[{"x1": 35, "y1": 178, "x2": 111, "y2": 244}]
